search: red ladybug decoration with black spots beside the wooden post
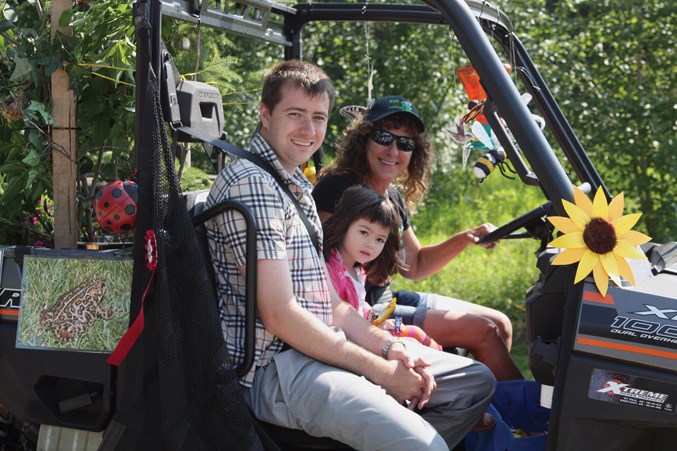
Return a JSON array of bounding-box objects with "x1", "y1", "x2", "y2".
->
[{"x1": 94, "y1": 180, "x2": 139, "y2": 233}]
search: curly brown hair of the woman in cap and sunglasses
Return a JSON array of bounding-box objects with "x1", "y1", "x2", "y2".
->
[{"x1": 321, "y1": 114, "x2": 431, "y2": 209}]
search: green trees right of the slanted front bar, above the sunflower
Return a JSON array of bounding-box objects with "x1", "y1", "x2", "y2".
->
[{"x1": 499, "y1": 0, "x2": 677, "y2": 242}]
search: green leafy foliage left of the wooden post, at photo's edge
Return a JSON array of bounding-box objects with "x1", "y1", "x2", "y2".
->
[{"x1": 0, "y1": 2, "x2": 53, "y2": 243}]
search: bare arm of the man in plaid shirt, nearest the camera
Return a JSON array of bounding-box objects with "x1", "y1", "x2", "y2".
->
[{"x1": 257, "y1": 260, "x2": 429, "y2": 402}]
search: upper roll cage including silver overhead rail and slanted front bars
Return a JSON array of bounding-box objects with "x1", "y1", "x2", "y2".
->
[{"x1": 148, "y1": 0, "x2": 610, "y2": 207}]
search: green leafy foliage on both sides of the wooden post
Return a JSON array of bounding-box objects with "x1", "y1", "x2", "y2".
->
[{"x1": 0, "y1": 0, "x2": 135, "y2": 244}]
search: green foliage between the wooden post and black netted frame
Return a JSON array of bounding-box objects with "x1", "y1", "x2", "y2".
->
[{"x1": 68, "y1": 0, "x2": 136, "y2": 180}]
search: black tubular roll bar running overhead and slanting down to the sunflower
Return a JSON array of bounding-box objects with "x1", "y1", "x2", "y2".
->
[{"x1": 285, "y1": 0, "x2": 608, "y2": 214}]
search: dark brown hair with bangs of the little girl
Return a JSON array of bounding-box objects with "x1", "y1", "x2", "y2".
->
[{"x1": 322, "y1": 186, "x2": 404, "y2": 285}]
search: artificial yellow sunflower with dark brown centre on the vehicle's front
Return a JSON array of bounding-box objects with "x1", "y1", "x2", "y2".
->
[{"x1": 548, "y1": 186, "x2": 651, "y2": 296}]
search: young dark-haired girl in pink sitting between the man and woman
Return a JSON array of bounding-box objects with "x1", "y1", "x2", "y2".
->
[{"x1": 322, "y1": 186, "x2": 442, "y2": 350}]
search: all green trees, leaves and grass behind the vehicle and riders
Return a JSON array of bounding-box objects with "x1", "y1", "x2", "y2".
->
[{"x1": 0, "y1": 0, "x2": 677, "y2": 374}]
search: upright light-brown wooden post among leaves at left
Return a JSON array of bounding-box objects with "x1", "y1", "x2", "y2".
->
[{"x1": 51, "y1": 0, "x2": 78, "y2": 249}]
